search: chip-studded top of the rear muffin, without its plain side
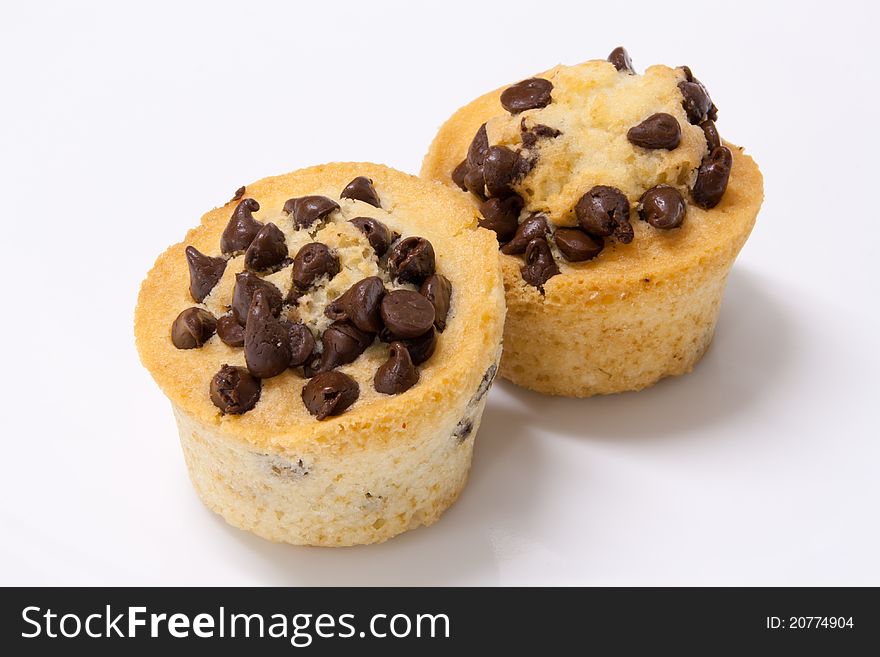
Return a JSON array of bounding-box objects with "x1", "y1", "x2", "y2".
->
[{"x1": 422, "y1": 48, "x2": 761, "y2": 295}]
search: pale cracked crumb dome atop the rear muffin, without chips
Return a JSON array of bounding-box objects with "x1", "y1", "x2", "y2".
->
[{"x1": 486, "y1": 61, "x2": 709, "y2": 220}]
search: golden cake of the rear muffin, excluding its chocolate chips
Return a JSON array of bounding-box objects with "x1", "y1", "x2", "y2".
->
[{"x1": 421, "y1": 52, "x2": 763, "y2": 397}]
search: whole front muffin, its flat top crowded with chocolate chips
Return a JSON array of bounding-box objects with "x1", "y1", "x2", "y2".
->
[{"x1": 135, "y1": 164, "x2": 504, "y2": 546}]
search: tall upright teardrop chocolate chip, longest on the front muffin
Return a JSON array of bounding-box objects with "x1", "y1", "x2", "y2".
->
[{"x1": 244, "y1": 290, "x2": 290, "y2": 379}]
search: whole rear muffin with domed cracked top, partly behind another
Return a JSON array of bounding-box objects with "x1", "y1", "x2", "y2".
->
[{"x1": 422, "y1": 48, "x2": 763, "y2": 397}]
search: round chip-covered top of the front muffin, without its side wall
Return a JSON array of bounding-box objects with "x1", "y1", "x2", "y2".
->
[{"x1": 136, "y1": 164, "x2": 503, "y2": 452}]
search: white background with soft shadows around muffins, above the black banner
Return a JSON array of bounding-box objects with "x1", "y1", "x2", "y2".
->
[{"x1": 0, "y1": 0, "x2": 880, "y2": 585}]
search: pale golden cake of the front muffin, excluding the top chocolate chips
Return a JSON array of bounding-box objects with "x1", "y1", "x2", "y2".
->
[{"x1": 135, "y1": 163, "x2": 505, "y2": 546}]
